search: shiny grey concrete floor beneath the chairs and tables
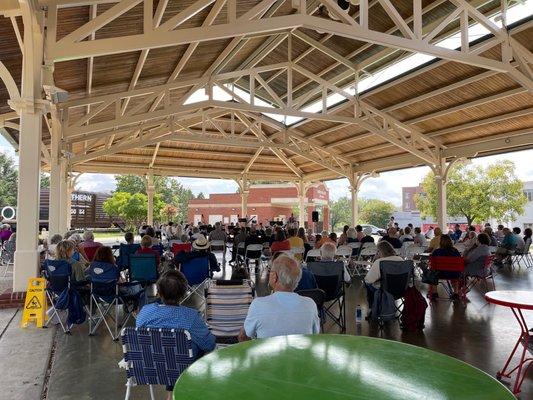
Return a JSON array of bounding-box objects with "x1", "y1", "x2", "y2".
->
[{"x1": 0, "y1": 256, "x2": 533, "y2": 400}]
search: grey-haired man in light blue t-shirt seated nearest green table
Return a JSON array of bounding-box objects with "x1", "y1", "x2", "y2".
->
[{"x1": 239, "y1": 254, "x2": 320, "y2": 341}]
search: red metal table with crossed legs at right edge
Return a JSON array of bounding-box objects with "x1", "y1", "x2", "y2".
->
[{"x1": 485, "y1": 290, "x2": 533, "y2": 395}]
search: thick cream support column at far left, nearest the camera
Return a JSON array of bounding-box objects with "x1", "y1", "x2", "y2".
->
[{"x1": 11, "y1": 2, "x2": 43, "y2": 292}]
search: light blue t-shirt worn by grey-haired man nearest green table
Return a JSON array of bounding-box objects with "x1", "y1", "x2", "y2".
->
[{"x1": 244, "y1": 292, "x2": 320, "y2": 338}]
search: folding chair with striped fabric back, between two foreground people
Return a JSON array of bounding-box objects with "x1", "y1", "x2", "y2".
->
[{"x1": 205, "y1": 280, "x2": 254, "y2": 344}]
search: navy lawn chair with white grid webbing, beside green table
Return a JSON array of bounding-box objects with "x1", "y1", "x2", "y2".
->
[{"x1": 121, "y1": 328, "x2": 195, "y2": 400}]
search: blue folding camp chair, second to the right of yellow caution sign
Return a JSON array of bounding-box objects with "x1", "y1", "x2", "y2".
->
[{"x1": 88, "y1": 261, "x2": 143, "y2": 340}]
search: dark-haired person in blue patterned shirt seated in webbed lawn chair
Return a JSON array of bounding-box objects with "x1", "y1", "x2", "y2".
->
[{"x1": 135, "y1": 271, "x2": 215, "y2": 400}]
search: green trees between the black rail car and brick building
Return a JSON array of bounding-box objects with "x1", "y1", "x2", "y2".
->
[{"x1": 115, "y1": 175, "x2": 194, "y2": 222}]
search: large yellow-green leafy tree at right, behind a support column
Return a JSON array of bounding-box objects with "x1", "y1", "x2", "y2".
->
[{"x1": 415, "y1": 160, "x2": 527, "y2": 225}]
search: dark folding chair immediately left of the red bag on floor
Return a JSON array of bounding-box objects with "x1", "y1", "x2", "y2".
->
[{"x1": 379, "y1": 260, "x2": 415, "y2": 328}]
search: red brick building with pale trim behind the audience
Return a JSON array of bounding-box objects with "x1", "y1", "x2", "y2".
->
[{"x1": 188, "y1": 183, "x2": 329, "y2": 230}]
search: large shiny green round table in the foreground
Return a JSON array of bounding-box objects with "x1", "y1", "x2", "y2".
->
[{"x1": 174, "y1": 335, "x2": 515, "y2": 400}]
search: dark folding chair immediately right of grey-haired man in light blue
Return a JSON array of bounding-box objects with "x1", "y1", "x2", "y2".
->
[{"x1": 307, "y1": 261, "x2": 346, "y2": 333}]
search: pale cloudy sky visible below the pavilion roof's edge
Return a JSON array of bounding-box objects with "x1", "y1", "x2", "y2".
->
[{"x1": 0, "y1": 136, "x2": 533, "y2": 207}]
